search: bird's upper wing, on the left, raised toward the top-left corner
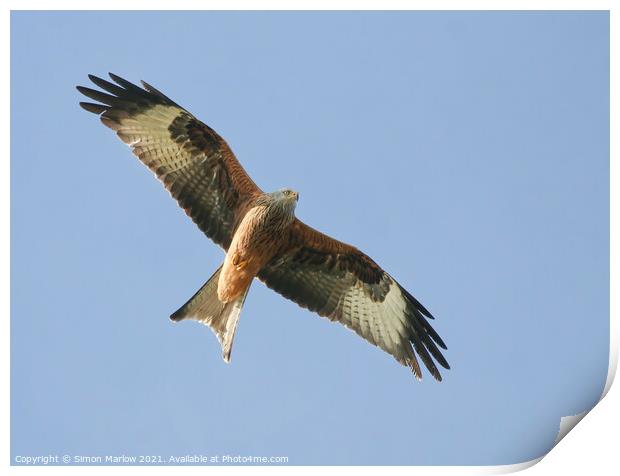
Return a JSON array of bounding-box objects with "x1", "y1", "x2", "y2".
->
[{"x1": 77, "y1": 74, "x2": 261, "y2": 249}]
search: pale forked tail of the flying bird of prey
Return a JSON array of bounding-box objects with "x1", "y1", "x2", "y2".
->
[{"x1": 170, "y1": 266, "x2": 250, "y2": 362}]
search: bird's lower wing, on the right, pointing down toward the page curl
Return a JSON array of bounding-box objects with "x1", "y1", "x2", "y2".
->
[{"x1": 258, "y1": 219, "x2": 450, "y2": 381}]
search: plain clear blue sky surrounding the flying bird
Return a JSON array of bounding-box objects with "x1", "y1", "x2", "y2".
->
[{"x1": 11, "y1": 12, "x2": 609, "y2": 465}]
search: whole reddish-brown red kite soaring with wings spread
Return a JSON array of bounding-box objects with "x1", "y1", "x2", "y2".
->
[{"x1": 77, "y1": 73, "x2": 450, "y2": 381}]
